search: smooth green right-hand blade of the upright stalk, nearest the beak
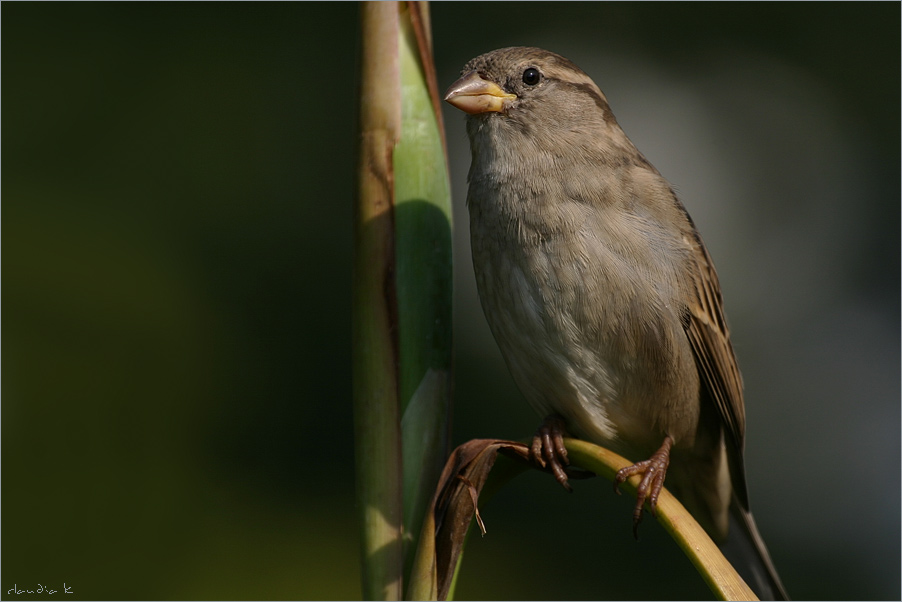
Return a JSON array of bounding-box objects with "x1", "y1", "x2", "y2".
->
[{"x1": 394, "y1": 3, "x2": 452, "y2": 575}]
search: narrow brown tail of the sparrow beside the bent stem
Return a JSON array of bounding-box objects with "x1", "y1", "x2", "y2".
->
[{"x1": 721, "y1": 498, "x2": 789, "y2": 600}]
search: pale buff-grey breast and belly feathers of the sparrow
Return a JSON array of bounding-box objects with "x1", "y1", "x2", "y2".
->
[{"x1": 469, "y1": 183, "x2": 694, "y2": 449}]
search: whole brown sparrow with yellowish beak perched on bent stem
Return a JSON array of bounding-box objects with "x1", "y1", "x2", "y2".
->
[{"x1": 445, "y1": 47, "x2": 788, "y2": 599}]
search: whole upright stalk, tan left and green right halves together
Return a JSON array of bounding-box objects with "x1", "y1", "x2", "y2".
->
[{"x1": 353, "y1": 2, "x2": 451, "y2": 600}]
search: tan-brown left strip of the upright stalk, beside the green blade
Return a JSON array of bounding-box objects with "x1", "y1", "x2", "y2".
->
[{"x1": 352, "y1": 2, "x2": 404, "y2": 600}]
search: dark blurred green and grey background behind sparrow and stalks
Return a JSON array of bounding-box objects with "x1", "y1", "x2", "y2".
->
[{"x1": 0, "y1": 3, "x2": 900, "y2": 599}]
